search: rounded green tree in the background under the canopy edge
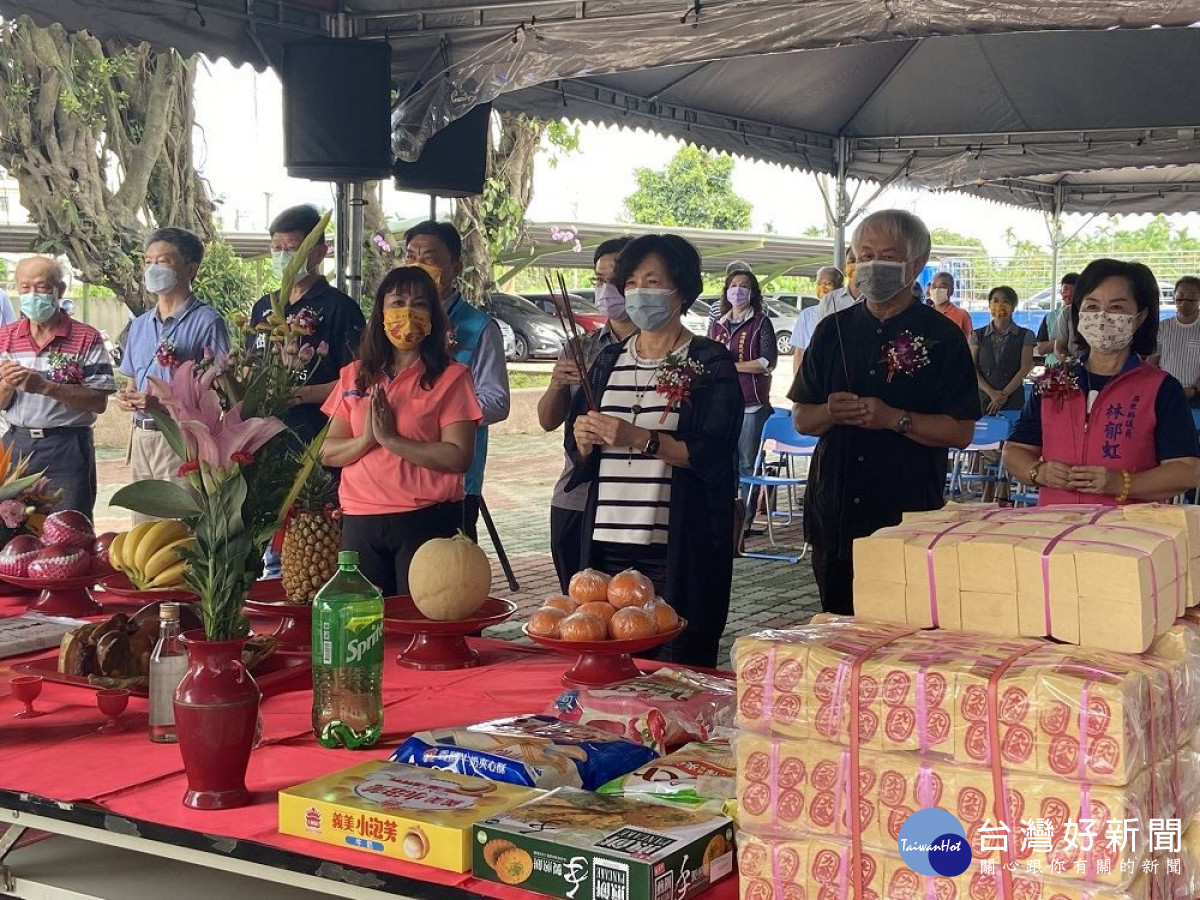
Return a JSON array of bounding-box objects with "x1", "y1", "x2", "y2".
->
[{"x1": 625, "y1": 145, "x2": 752, "y2": 232}]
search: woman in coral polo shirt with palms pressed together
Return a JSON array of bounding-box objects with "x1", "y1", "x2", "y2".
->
[{"x1": 320, "y1": 265, "x2": 484, "y2": 596}]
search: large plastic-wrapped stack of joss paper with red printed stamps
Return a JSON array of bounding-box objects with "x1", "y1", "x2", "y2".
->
[{"x1": 733, "y1": 614, "x2": 1200, "y2": 900}]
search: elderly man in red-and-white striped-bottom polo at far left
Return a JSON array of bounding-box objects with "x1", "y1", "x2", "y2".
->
[{"x1": 0, "y1": 257, "x2": 116, "y2": 518}]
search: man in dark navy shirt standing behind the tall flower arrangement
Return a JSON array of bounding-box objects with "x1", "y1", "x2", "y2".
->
[{"x1": 250, "y1": 204, "x2": 366, "y2": 444}]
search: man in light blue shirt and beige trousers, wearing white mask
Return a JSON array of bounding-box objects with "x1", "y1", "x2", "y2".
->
[{"x1": 116, "y1": 228, "x2": 229, "y2": 524}]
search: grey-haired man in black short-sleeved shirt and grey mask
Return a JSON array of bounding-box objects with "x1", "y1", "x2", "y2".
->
[{"x1": 788, "y1": 210, "x2": 979, "y2": 614}]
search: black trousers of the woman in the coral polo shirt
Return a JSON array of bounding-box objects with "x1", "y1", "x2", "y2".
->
[{"x1": 342, "y1": 502, "x2": 462, "y2": 596}]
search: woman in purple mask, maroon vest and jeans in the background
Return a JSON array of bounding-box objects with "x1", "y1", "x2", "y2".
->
[{"x1": 710, "y1": 264, "x2": 779, "y2": 526}]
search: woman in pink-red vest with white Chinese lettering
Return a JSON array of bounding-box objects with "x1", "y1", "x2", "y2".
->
[{"x1": 1004, "y1": 259, "x2": 1200, "y2": 506}]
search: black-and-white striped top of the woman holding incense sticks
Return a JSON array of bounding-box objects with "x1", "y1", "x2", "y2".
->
[{"x1": 592, "y1": 341, "x2": 688, "y2": 545}]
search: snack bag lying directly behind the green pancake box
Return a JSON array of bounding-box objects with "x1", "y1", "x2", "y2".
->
[{"x1": 600, "y1": 743, "x2": 737, "y2": 818}]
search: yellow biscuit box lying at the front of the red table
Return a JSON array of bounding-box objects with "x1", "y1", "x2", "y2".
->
[{"x1": 280, "y1": 761, "x2": 541, "y2": 872}]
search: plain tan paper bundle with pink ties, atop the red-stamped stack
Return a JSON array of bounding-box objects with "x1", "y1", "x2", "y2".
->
[{"x1": 854, "y1": 504, "x2": 1200, "y2": 653}]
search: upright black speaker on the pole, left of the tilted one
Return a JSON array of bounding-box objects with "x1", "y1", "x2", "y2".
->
[{"x1": 280, "y1": 37, "x2": 392, "y2": 181}]
